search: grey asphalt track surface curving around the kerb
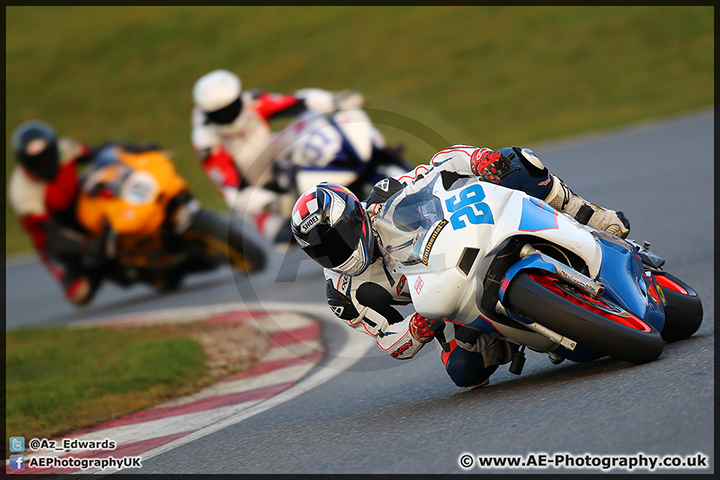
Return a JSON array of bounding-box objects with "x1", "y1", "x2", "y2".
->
[{"x1": 6, "y1": 111, "x2": 715, "y2": 474}]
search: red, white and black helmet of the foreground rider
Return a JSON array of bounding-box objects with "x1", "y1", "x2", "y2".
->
[{"x1": 291, "y1": 182, "x2": 372, "y2": 275}]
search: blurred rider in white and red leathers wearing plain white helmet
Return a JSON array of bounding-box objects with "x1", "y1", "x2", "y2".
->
[{"x1": 192, "y1": 69, "x2": 364, "y2": 243}]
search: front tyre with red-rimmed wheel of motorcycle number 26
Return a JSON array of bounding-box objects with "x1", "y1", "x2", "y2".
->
[{"x1": 503, "y1": 272, "x2": 663, "y2": 364}]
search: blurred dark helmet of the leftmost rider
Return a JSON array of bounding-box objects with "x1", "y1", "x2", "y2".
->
[{"x1": 13, "y1": 120, "x2": 60, "y2": 180}]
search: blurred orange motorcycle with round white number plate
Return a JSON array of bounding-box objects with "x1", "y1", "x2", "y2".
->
[{"x1": 76, "y1": 143, "x2": 266, "y2": 290}]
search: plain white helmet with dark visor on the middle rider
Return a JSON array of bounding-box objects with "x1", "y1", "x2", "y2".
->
[{"x1": 193, "y1": 70, "x2": 242, "y2": 124}]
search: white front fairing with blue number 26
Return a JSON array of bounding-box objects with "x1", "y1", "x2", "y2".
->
[{"x1": 386, "y1": 177, "x2": 602, "y2": 318}]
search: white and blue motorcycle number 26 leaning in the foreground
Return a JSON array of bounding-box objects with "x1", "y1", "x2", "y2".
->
[{"x1": 374, "y1": 172, "x2": 703, "y2": 374}]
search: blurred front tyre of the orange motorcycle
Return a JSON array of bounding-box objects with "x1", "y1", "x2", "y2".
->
[{"x1": 184, "y1": 210, "x2": 267, "y2": 273}]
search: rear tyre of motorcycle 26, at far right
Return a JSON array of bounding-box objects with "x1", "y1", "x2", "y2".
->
[{"x1": 654, "y1": 272, "x2": 703, "y2": 342}]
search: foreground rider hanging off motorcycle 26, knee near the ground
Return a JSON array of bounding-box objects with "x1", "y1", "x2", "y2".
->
[{"x1": 291, "y1": 145, "x2": 630, "y2": 387}]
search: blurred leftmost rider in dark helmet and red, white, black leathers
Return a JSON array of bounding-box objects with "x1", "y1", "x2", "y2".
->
[{"x1": 8, "y1": 120, "x2": 108, "y2": 306}]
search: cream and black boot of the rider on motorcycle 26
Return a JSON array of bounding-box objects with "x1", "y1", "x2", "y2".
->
[{"x1": 545, "y1": 175, "x2": 630, "y2": 238}]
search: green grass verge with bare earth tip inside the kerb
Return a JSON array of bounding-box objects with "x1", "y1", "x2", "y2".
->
[{"x1": 5, "y1": 322, "x2": 266, "y2": 454}]
